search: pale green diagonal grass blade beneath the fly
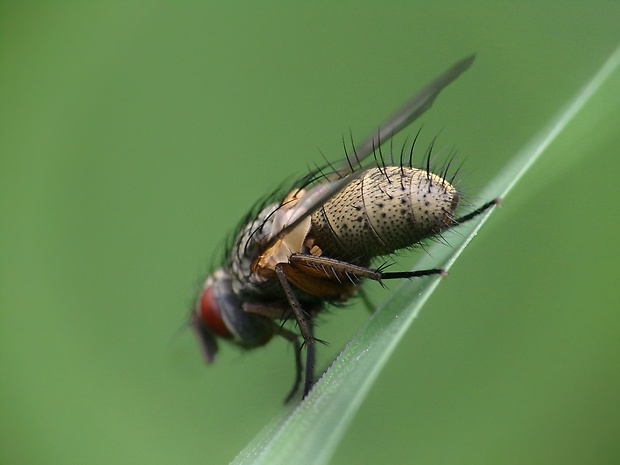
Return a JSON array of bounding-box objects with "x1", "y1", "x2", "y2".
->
[{"x1": 232, "y1": 48, "x2": 620, "y2": 465}]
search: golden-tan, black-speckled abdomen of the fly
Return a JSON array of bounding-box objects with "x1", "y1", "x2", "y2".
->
[{"x1": 310, "y1": 166, "x2": 459, "y2": 260}]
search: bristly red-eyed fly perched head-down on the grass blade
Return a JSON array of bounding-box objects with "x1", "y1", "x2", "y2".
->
[{"x1": 190, "y1": 56, "x2": 497, "y2": 400}]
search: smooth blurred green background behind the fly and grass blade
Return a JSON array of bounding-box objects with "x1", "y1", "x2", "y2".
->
[{"x1": 0, "y1": 1, "x2": 620, "y2": 465}]
